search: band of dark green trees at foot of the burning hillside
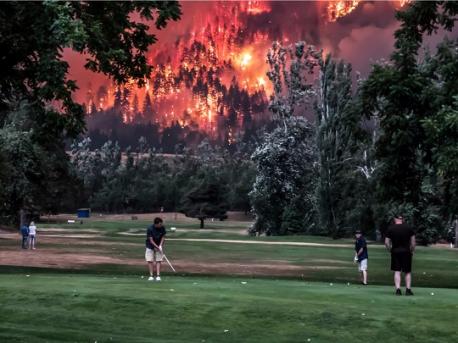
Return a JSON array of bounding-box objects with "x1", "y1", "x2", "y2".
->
[{"x1": 71, "y1": 137, "x2": 254, "y2": 219}]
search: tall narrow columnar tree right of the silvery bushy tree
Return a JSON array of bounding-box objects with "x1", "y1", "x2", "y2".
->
[{"x1": 315, "y1": 55, "x2": 370, "y2": 238}]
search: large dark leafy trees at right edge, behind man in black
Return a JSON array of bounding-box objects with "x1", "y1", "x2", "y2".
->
[{"x1": 361, "y1": 1, "x2": 458, "y2": 243}]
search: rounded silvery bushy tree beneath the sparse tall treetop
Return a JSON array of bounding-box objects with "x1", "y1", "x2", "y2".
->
[{"x1": 250, "y1": 117, "x2": 317, "y2": 235}]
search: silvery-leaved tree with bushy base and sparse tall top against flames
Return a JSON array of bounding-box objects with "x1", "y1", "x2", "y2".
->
[{"x1": 250, "y1": 42, "x2": 321, "y2": 235}]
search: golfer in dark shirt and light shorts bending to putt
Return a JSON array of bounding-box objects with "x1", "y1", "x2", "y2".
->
[{"x1": 145, "y1": 218, "x2": 165, "y2": 281}]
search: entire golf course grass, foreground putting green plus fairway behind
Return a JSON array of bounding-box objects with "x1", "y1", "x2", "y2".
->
[{"x1": 0, "y1": 219, "x2": 458, "y2": 343}]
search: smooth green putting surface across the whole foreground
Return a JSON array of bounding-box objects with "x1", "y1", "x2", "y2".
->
[{"x1": 0, "y1": 272, "x2": 458, "y2": 342}]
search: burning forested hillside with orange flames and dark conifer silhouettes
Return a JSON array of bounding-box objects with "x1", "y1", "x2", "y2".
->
[{"x1": 78, "y1": 1, "x2": 404, "y2": 150}]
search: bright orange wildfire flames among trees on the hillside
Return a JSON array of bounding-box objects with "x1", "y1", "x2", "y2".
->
[{"x1": 86, "y1": 0, "x2": 412, "y2": 141}]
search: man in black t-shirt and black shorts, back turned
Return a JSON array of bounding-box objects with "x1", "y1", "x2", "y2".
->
[{"x1": 385, "y1": 216, "x2": 415, "y2": 295}]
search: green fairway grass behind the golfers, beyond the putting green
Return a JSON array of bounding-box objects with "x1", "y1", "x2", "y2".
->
[{"x1": 8, "y1": 220, "x2": 458, "y2": 288}]
